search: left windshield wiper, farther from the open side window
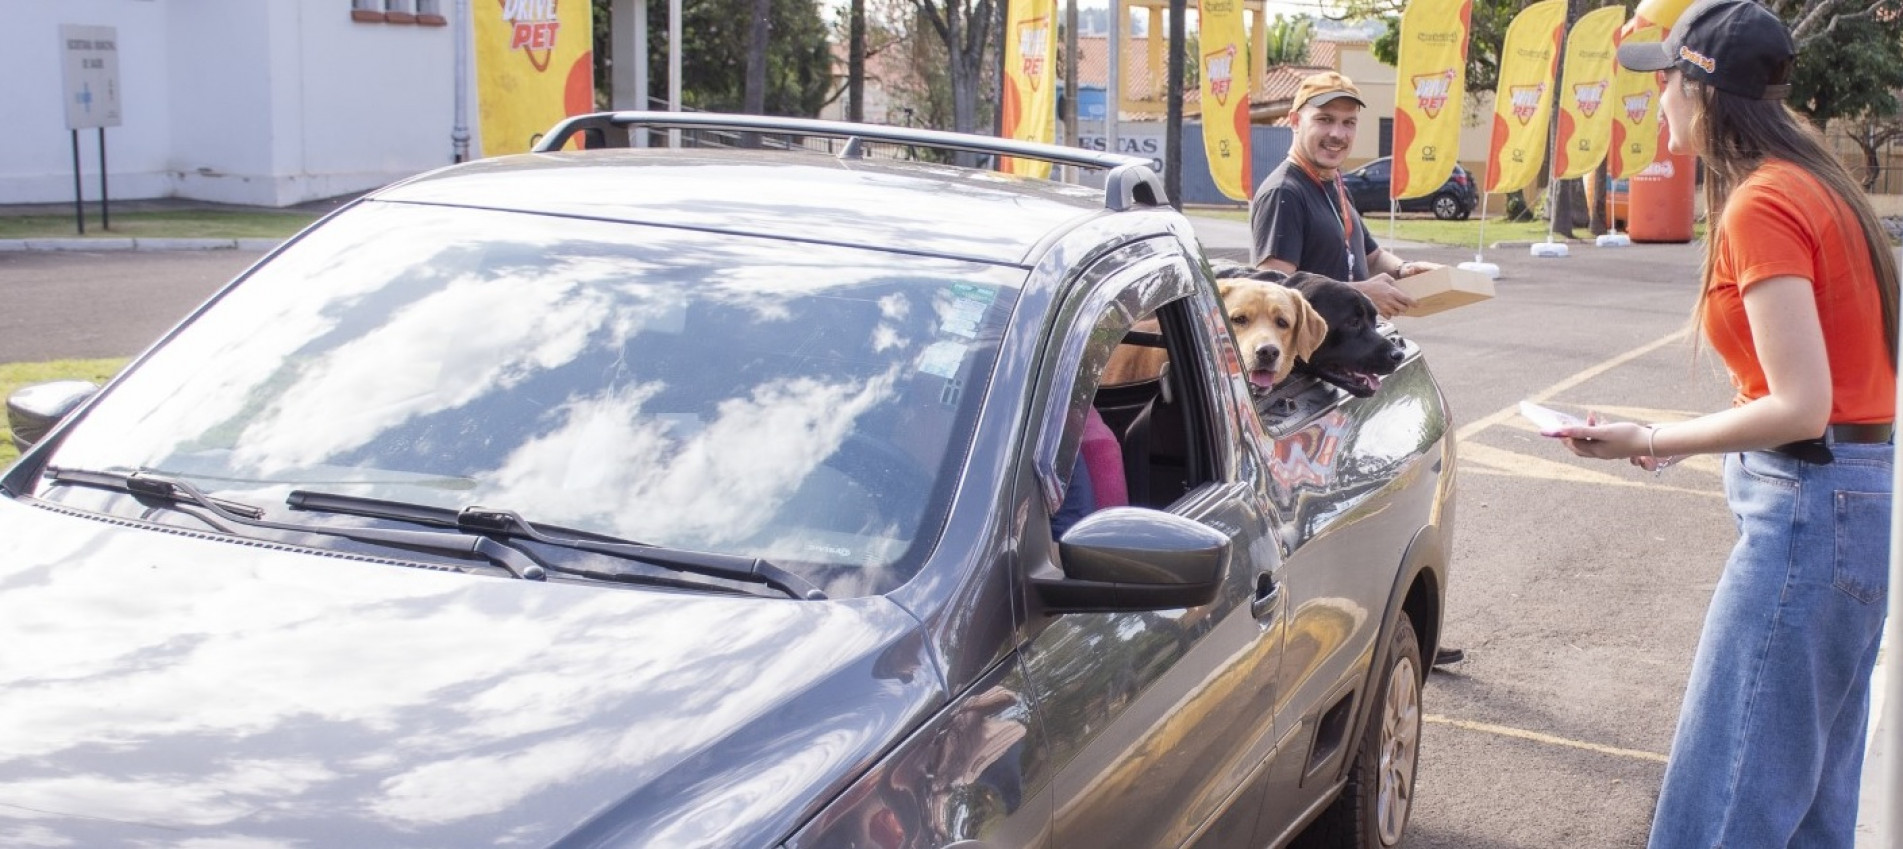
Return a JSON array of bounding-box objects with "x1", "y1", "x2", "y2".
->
[{"x1": 46, "y1": 466, "x2": 546, "y2": 581}]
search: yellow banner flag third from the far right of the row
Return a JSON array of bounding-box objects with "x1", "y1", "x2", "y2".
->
[{"x1": 1486, "y1": 0, "x2": 1566, "y2": 192}]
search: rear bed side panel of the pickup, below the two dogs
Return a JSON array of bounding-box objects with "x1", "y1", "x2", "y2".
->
[{"x1": 1256, "y1": 343, "x2": 1448, "y2": 839}]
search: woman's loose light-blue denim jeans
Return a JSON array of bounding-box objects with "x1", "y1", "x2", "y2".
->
[{"x1": 1650, "y1": 445, "x2": 1892, "y2": 849}]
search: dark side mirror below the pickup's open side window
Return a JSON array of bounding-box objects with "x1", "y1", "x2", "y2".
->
[{"x1": 1031, "y1": 506, "x2": 1229, "y2": 613}]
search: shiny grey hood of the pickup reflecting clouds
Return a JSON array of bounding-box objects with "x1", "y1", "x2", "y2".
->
[{"x1": 0, "y1": 499, "x2": 942, "y2": 847}]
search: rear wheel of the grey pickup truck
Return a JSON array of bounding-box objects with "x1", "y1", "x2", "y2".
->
[{"x1": 1294, "y1": 613, "x2": 1427, "y2": 849}]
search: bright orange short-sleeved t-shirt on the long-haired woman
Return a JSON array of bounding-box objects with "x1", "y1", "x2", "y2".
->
[{"x1": 1705, "y1": 160, "x2": 1895, "y2": 425}]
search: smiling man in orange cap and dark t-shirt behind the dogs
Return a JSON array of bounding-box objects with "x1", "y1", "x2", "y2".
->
[{"x1": 1248, "y1": 70, "x2": 1439, "y2": 318}]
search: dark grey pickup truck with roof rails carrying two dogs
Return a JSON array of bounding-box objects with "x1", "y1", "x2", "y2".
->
[{"x1": 0, "y1": 112, "x2": 1454, "y2": 849}]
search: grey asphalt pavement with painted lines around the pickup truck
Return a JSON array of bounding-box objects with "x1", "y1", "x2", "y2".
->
[{"x1": 0, "y1": 235, "x2": 1874, "y2": 849}]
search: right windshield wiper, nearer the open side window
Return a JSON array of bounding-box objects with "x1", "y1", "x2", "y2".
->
[{"x1": 285, "y1": 489, "x2": 826, "y2": 602}]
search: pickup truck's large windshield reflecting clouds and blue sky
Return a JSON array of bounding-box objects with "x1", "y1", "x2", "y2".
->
[{"x1": 37, "y1": 204, "x2": 1022, "y2": 594}]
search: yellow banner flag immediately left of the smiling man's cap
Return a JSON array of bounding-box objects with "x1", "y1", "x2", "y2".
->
[{"x1": 1197, "y1": 0, "x2": 1256, "y2": 200}]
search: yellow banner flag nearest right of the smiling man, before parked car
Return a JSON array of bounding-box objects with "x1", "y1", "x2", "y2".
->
[{"x1": 1389, "y1": 0, "x2": 1473, "y2": 200}]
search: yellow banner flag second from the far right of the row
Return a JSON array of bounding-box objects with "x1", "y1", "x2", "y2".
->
[{"x1": 1553, "y1": 6, "x2": 1625, "y2": 179}]
